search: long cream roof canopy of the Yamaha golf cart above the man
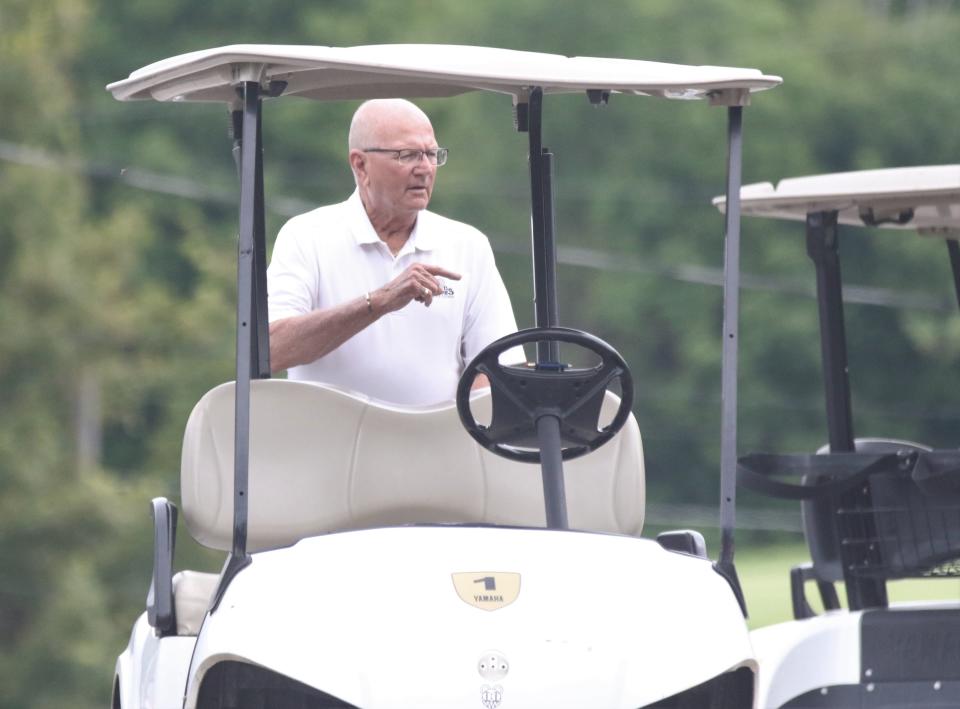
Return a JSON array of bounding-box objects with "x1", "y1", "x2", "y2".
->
[{"x1": 107, "y1": 44, "x2": 781, "y2": 105}]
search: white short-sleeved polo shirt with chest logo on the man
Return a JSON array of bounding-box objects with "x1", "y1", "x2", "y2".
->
[{"x1": 267, "y1": 192, "x2": 522, "y2": 405}]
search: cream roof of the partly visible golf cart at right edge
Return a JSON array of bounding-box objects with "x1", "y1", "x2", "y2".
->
[{"x1": 713, "y1": 165, "x2": 960, "y2": 233}]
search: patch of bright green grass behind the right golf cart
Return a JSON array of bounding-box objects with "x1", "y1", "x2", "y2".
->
[{"x1": 736, "y1": 543, "x2": 960, "y2": 628}]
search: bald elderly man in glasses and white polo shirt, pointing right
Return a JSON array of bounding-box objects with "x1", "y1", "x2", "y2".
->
[{"x1": 267, "y1": 99, "x2": 522, "y2": 404}]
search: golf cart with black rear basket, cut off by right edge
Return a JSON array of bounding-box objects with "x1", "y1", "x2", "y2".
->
[{"x1": 714, "y1": 165, "x2": 960, "y2": 709}]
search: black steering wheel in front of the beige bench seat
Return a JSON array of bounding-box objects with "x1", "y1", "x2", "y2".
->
[{"x1": 457, "y1": 327, "x2": 633, "y2": 463}]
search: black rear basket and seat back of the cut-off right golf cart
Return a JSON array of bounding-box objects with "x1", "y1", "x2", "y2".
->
[{"x1": 738, "y1": 448, "x2": 960, "y2": 581}]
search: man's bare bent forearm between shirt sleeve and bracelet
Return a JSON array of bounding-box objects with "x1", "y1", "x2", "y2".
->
[{"x1": 270, "y1": 293, "x2": 383, "y2": 372}]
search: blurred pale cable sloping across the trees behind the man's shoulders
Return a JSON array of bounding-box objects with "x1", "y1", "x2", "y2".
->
[{"x1": 0, "y1": 140, "x2": 955, "y2": 312}]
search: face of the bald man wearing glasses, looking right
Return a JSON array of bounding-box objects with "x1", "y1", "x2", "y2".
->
[{"x1": 362, "y1": 115, "x2": 437, "y2": 216}]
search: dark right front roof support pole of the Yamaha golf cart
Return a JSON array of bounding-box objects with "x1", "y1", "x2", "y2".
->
[{"x1": 719, "y1": 106, "x2": 743, "y2": 572}]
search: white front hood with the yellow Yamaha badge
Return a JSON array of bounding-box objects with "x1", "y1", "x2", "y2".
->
[{"x1": 187, "y1": 527, "x2": 753, "y2": 709}]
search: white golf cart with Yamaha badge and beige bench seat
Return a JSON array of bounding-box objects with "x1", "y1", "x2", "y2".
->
[{"x1": 108, "y1": 45, "x2": 780, "y2": 709}]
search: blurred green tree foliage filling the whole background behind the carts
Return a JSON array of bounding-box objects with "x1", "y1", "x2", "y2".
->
[{"x1": 0, "y1": 0, "x2": 960, "y2": 708}]
